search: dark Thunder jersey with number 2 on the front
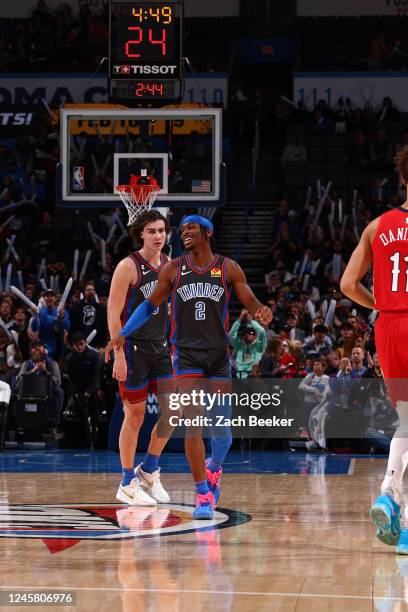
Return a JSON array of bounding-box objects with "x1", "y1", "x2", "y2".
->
[{"x1": 170, "y1": 254, "x2": 230, "y2": 349}]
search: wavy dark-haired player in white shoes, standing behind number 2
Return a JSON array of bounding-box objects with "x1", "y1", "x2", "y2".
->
[{"x1": 108, "y1": 211, "x2": 173, "y2": 506}]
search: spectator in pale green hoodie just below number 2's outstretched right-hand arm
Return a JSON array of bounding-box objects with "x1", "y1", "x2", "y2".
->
[{"x1": 230, "y1": 310, "x2": 266, "y2": 378}]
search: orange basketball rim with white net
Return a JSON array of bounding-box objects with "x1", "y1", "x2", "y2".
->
[{"x1": 116, "y1": 174, "x2": 160, "y2": 225}]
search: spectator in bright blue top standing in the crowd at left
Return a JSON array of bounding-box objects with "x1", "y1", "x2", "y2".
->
[{"x1": 28, "y1": 289, "x2": 70, "y2": 360}]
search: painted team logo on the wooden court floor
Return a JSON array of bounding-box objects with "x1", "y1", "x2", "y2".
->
[{"x1": 0, "y1": 504, "x2": 251, "y2": 553}]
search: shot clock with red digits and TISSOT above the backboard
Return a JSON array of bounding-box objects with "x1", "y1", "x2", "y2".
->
[{"x1": 109, "y1": 0, "x2": 183, "y2": 105}]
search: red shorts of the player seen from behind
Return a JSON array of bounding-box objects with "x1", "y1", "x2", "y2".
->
[{"x1": 375, "y1": 312, "x2": 408, "y2": 403}]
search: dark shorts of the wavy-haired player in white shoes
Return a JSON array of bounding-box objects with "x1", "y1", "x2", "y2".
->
[{"x1": 119, "y1": 339, "x2": 174, "y2": 404}]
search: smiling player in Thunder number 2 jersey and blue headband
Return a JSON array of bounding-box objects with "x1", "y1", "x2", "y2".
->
[{"x1": 105, "y1": 215, "x2": 272, "y2": 519}]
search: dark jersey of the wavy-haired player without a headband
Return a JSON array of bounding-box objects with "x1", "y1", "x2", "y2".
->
[{"x1": 121, "y1": 251, "x2": 168, "y2": 350}]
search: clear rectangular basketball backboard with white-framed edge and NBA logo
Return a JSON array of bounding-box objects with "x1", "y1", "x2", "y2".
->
[{"x1": 58, "y1": 107, "x2": 224, "y2": 207}]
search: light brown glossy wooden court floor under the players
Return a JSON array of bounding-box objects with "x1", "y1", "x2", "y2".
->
[{"x1": 0, "y1": 459, "x2": 408, "y2": 612}]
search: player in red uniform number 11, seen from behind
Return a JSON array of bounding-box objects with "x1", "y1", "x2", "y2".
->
[{"x1": 341, "y1": 147, "x2": 408, "y2": 553}]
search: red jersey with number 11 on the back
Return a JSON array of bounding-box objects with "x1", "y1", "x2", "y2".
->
[{"x1": 372, "y1": 207, "x2": 408, "y2": 312}]
